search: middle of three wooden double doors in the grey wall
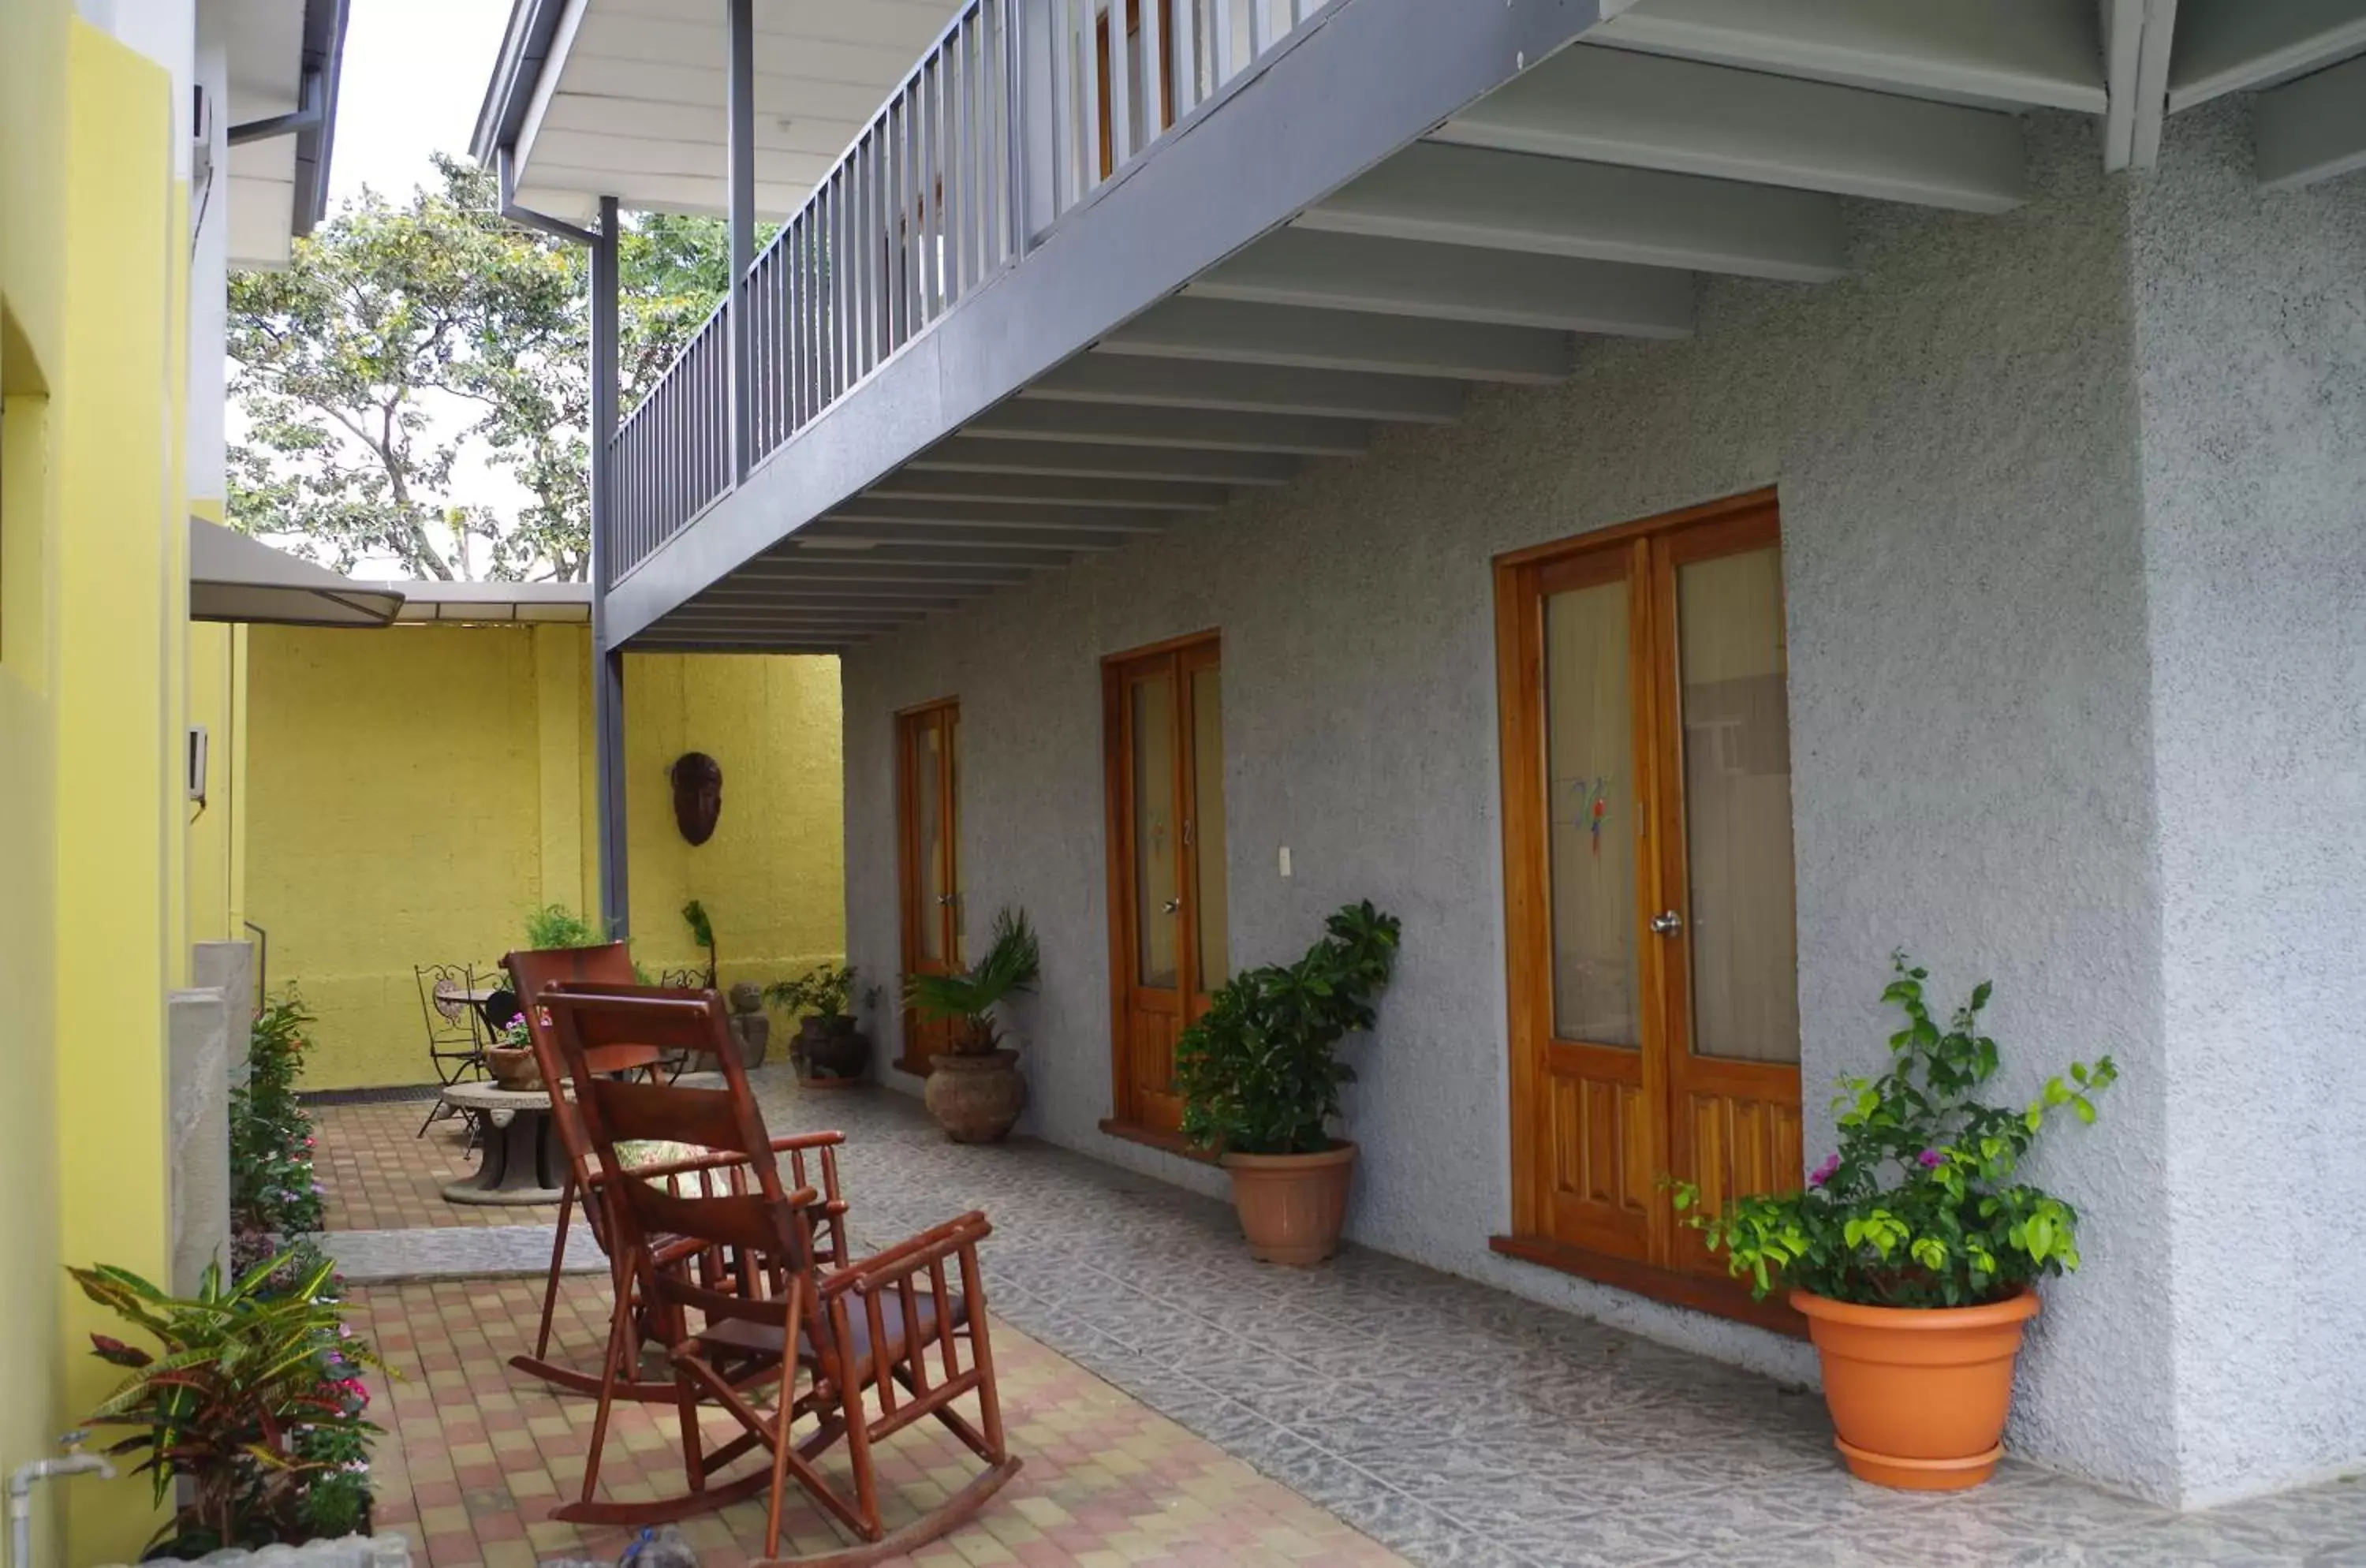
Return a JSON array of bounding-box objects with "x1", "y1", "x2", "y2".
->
[{"x1": 1103, "y1": 637, "x2": 1226, "y2": 1133}]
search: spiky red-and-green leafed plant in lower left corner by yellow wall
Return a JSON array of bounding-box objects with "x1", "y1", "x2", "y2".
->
[{"x1": 66, "y1": 1253, "x2": 381, "y2": 1556}]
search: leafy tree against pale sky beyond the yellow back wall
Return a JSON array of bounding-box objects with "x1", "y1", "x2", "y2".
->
[{"x1": 230, "y1": 154, "x2": 748, "y2": 582}]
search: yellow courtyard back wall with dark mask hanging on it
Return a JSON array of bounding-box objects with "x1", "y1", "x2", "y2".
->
[{"x1": 244, "y1": 627, "x2": 845, "y2": 1088}]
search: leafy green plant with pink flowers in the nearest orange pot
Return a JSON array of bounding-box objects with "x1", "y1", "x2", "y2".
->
[{"x1": 1673, "y1": 953, "x2": 2120, "y2": 1308}]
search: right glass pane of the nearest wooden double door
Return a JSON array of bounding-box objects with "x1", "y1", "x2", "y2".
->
[{"x1": 1675, "y1": 549, "x2": 1798, "y2": 1062}]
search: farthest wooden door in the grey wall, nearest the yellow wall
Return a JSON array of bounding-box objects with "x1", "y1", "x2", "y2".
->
[{"x1": 894, "y1": 700, "x2": 963, "y2": 1073}]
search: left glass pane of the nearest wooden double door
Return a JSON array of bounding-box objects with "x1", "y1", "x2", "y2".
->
[{"x1": 1545, "y1": 582, "x2": 1640, "y2": 1045}]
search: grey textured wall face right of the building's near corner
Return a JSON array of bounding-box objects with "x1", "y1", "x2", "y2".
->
[{"x1": 2134, "y1": 106, "x2": 2366, "y2": 1502}]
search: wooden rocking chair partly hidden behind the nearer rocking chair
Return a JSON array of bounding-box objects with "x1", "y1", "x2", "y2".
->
[{"x1": 502, "y1": 941, "x2": 847, "y2": 1405}]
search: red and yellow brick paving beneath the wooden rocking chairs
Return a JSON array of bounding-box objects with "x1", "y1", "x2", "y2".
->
[{"x1": 355, "y1": 1277, "x2": 1403, "y2": 1568}]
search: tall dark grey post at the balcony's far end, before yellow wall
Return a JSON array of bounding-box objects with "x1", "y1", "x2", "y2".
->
[{"x1": 592, "y1": 196, "x2": 632, "y2": 941}]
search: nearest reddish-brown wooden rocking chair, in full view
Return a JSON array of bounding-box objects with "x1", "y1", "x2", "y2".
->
[{"x1": 544, "y1": 986, "x2": 1020, "y2": 1568}]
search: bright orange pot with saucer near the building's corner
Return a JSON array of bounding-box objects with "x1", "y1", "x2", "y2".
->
[{"x1": 1791, "y1": 1286, "x2": 2037, "y2": 1492}]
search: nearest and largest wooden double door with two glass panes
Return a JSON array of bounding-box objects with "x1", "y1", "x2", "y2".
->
[{"x1": 1495, "y1": 492, "x2": 1801, "y2": 1305}]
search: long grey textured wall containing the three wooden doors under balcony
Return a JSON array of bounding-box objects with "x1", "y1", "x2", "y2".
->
[{"x1": 845, "y1": 118, "x2": 2174, "y2": 1495}]
